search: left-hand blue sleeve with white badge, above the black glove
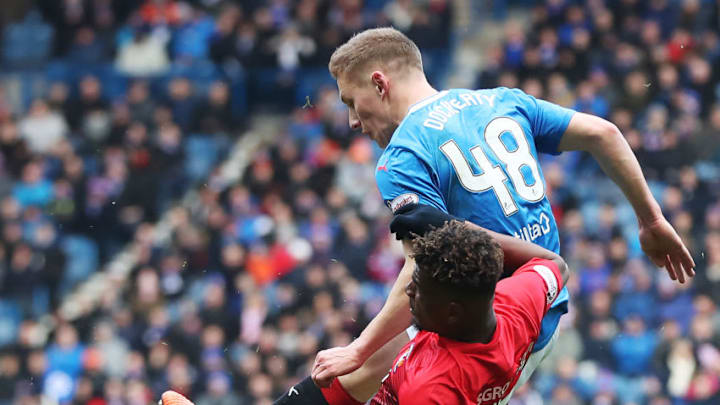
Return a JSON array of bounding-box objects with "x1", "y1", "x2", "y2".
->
[{"x1": 375, "y1": 146, "x2": 447, "y2": 213}]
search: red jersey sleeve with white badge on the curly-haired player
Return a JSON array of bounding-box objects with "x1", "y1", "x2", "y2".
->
[{"x1": 495, "y1": 258, "x2": 563, "y2": 331}]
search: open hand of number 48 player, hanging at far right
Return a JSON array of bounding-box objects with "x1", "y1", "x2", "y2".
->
[{"x1": 640, "y1": 218, "x2": 695, "y2": 283}]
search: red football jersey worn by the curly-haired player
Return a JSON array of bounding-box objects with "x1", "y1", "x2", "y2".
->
[{"x1": 371, "y1": 259, "x2": 563, "y2": 405}]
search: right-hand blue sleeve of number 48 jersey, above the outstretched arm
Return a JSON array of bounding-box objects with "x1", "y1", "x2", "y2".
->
[{"x1": 513, "y1": 90, "x2": 575, "y2": 155}]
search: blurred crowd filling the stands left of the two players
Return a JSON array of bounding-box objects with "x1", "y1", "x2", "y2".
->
[{"x1": 0, "y1": 0, "x2": 451, "y2": 405}]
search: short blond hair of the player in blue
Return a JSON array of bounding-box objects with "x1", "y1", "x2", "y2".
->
[{"x1": 328, "y1": 27, "x2": 423, "y2": 79}]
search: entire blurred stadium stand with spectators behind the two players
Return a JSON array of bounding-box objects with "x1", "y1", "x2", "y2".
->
[{"x1": 0, "y1": 0, "x2": 720, "y2": 405}]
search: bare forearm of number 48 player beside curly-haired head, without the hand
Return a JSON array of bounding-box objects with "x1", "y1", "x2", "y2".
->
[{"x1": 352, "y1": 242, "x2": 415, "y2": 360}]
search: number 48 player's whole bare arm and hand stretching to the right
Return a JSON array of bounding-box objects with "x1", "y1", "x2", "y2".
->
[{"x1": 558, "y1": 113, "x2": 695, "y2": 283}]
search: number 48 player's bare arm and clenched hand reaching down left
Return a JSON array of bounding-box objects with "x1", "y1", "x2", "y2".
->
[{"x1": 310, "y1": 241, "x2": 415, "y2": 387}]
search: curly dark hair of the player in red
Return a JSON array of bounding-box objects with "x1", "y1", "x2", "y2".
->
[{"x1": 413, "y1": 221, "x2": 503, "y2": 293}]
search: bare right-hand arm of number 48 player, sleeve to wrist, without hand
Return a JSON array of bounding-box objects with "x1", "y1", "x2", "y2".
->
[{"x1": 560, "y1": 113, "x2": 662, "y2": 224}]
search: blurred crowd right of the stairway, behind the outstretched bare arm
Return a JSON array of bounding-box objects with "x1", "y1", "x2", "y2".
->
[{"x1": 476, "y1": 0, "x2": 720, "y2": 405}]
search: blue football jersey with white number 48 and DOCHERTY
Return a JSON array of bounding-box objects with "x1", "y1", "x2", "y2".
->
[{"x1": 375, "y1": 87, "x2": 574, "y2": 350}]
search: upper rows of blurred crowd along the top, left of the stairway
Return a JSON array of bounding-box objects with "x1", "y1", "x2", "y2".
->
[{"x1": 0, "y1": 0, "x2": 452, "y2": 112}]
